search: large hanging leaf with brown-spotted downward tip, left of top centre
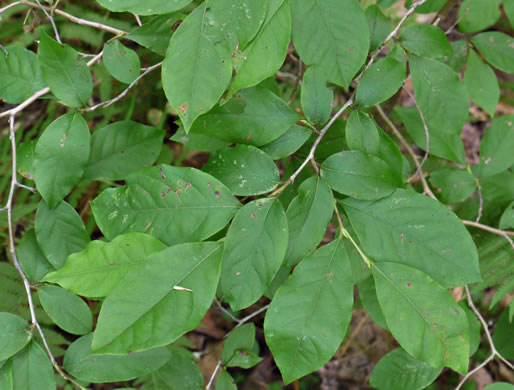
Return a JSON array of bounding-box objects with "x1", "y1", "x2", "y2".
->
[{"x1": 162, "y1": 1, "x2": 232, "y2": 133}]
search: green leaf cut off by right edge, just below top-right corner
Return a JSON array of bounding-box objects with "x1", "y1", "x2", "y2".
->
[{"x1": 471, "y1": 31, "x2": 514, "y2": 73}]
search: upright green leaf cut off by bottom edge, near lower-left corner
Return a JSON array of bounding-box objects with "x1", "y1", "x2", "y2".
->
[{"x1": 12, "y1": 341, "x2": 57, "y2": 390}]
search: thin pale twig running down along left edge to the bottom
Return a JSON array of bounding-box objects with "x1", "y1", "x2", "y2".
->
[{"x1": 3, "y1": 114, "x2": 85, "y2": 390}]
